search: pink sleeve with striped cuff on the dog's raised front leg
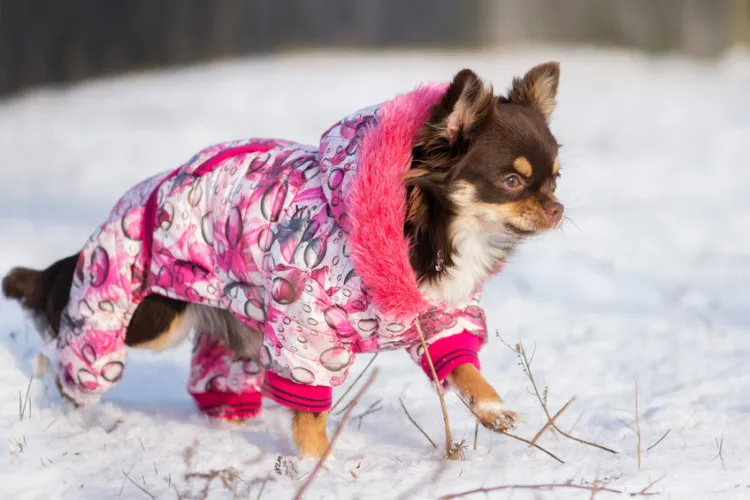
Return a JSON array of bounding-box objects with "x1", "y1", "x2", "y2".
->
[{"x1": 407, "y1": 292, "x2": 487, "y2": 382}]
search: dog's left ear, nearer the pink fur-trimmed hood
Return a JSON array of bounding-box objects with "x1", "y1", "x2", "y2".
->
[{"x1": 429, "y1": 69, "x2": 494, "y2": 147}]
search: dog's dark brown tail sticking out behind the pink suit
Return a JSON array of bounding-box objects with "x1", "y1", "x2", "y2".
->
[{"x1": 3, "y1": 254, "x2": 78, "y2": 338}]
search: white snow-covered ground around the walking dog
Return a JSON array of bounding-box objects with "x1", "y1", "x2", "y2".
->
[{"x1": 0, "y1": 48, "x2": 750, "y2": 499}]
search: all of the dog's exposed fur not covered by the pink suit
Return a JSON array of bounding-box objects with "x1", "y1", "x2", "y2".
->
[{"x1": 2, "y1": 63, "x2": 563, "y2": 458}]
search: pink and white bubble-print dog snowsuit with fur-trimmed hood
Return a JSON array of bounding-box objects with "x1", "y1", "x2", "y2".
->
[{"x1": 57, "y1": 86, "x2": 494, "y2": 417}]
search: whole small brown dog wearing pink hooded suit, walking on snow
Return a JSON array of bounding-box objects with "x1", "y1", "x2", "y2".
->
[{"x1": 3, "y1": 63, "x2": 563, "y2": 457}]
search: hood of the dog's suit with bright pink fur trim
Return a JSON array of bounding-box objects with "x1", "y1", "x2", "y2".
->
[{"x1": 320, "y1": 84, "x2": 447, "y2": 323}]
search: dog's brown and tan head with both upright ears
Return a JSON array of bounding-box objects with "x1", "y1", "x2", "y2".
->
[{"x1": 408, "y1": 63, "x2": 563, "y2": 237}]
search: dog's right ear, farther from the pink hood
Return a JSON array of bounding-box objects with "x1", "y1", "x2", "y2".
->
[{"x1": 508, "y1": 61, "x2": 560, "y2": 123}]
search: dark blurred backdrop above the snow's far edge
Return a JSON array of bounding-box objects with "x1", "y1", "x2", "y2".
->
[{"x1": 0, "y1": 0, "x2": 750, "y2": 95}]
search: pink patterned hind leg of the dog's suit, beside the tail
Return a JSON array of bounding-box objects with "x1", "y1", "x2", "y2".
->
[{"x1": 57, "y1": 218, "x2": 134, "y2": 406}]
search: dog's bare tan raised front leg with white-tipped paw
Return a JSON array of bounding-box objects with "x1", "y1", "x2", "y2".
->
[{"x1": 448, "y1": 363, "x2": 518, "y2": 432}]
